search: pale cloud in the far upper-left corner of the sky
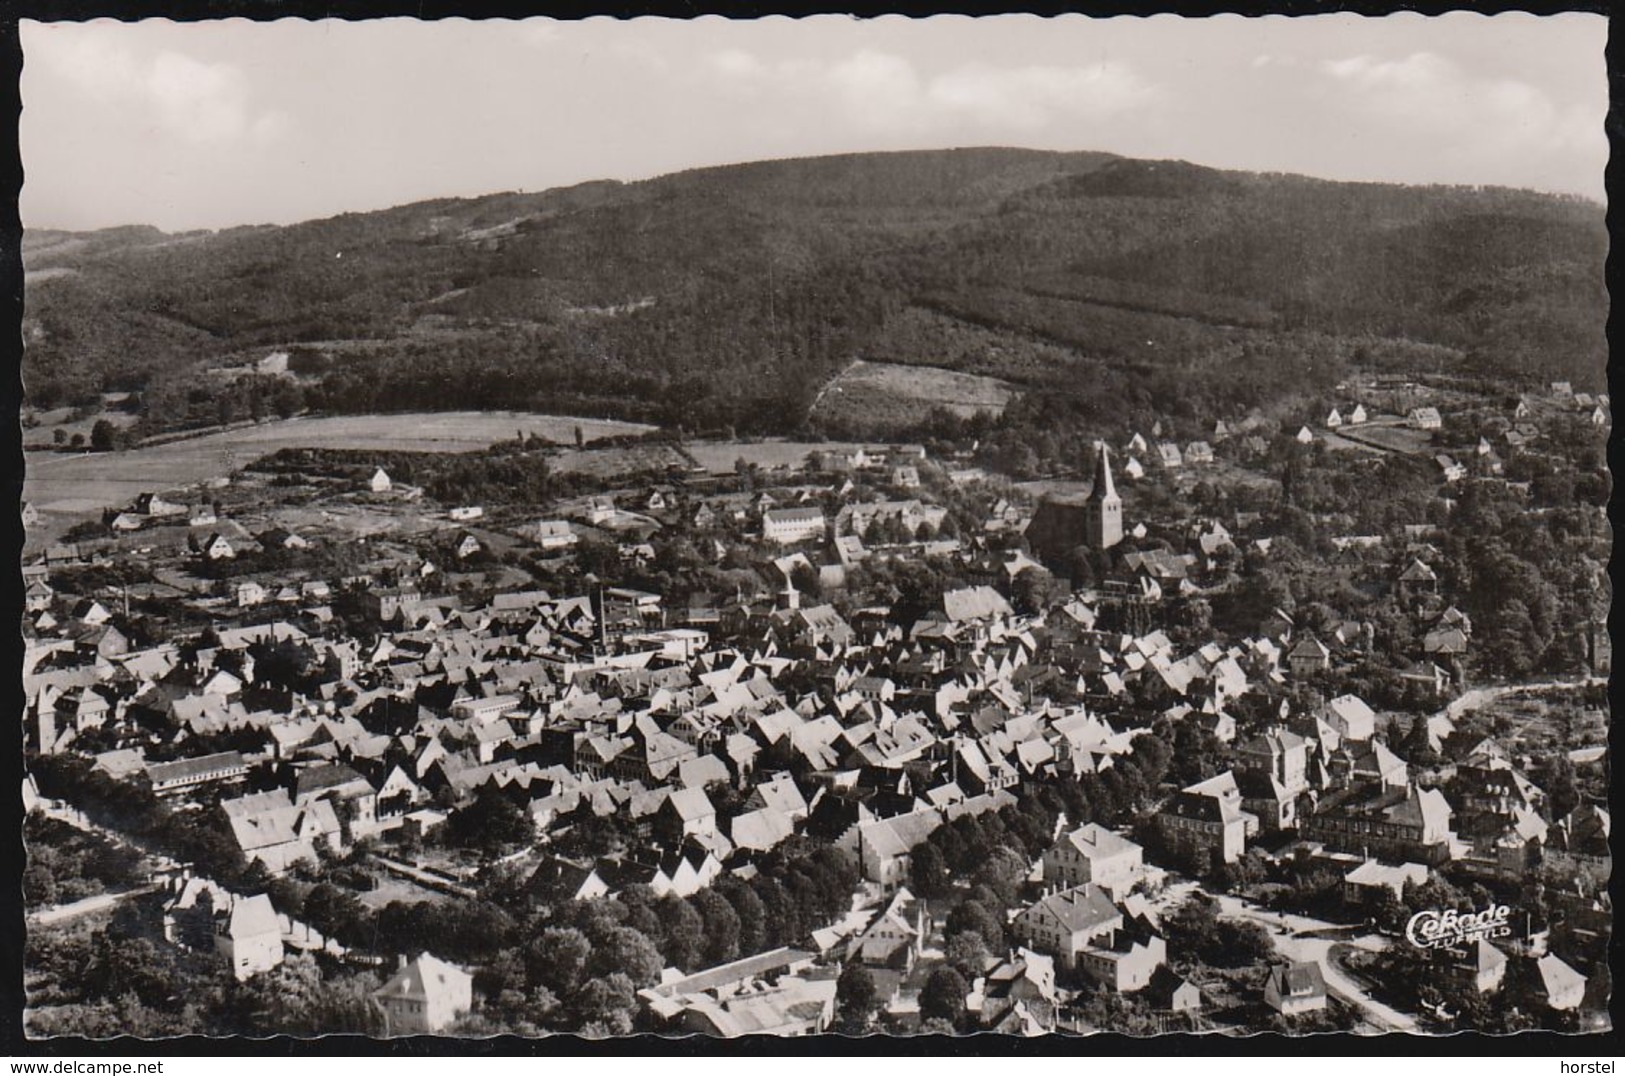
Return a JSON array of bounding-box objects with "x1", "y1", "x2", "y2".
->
[{"x1": 24, "y1": 26, "x2": 291, "y2": 145}]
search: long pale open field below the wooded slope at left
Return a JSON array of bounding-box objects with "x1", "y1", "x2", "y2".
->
[{"x1": 23, "y1": 411, "x2": 652, "y2": 549}]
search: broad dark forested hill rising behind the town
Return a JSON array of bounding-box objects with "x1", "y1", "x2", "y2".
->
[{"x1": 24, "y1": 150, "x2": 1607, "y2": 432}]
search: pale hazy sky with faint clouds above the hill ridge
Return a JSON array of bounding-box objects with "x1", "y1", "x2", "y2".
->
[{"x1": 20, "y1": 13, "x2": 1607, "y2": 231}]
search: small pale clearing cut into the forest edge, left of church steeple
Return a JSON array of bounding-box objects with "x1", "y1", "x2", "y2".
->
[{"x1": 813, "y1": 359, "x2": 1016, "y2": 424}]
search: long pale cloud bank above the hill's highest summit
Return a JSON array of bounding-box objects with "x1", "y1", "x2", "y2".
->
[{"x1": 707, "y1": 49, "x2": 1160, "y2": 132}]
